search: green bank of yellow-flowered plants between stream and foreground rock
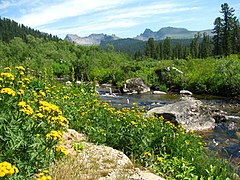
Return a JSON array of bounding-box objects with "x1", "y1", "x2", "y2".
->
[{"x1": 0, "y1": 66, "x2": 235, "y2": 179}]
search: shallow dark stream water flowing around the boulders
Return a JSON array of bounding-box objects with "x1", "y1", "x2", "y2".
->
[{"x1": 99, "y1": 89, "x2": 240, "y2": 166}]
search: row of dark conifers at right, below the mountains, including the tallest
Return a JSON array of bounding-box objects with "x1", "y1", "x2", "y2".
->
[{"x1": 142, "y1": 3, "x2": 240, "y2": 60}]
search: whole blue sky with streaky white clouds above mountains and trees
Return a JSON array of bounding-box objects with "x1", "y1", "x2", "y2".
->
[{"x1": 0, "y1": 0, "x2": 240, "y2": 38}]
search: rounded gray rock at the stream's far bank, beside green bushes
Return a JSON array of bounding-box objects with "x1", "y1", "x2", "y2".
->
[{"x1": 123, "y1": 78, "x2": 150, "y2": 93}]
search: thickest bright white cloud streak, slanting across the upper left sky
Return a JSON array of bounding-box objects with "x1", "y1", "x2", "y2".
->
[{"x1": 17, "y1": 0, "x2": 126, "y2": 27}]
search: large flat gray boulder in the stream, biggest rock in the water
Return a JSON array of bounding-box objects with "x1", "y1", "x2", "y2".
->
[{"x1": 147, "y1": 97, "x2": 227, "y2": 131}]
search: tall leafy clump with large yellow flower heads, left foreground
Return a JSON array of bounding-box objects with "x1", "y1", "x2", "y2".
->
[{"x1": 0, "y1": 66, "x2": 68, "y2": 179}]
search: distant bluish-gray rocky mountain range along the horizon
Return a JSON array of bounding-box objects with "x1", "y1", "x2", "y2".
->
[{"x1": 65, "y1": 27, "x2": 213, "y2": 45}]
